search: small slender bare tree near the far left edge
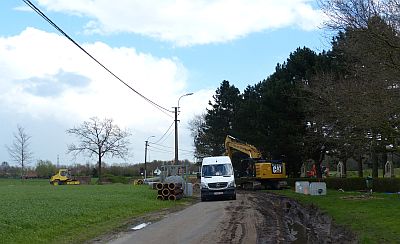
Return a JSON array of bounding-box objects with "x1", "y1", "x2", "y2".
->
[{"x1": 6, "y1": 125, "x2": 33, "y2": 179}]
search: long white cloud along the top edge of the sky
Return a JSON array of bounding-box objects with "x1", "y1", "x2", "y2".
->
[{"x1": 34, "y1": 0, "x2": 324, "y2": 46}]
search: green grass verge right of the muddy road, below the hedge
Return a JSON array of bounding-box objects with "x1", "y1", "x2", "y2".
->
[{"x1": 274, "y1": 189, "x2": 400, "y2": 243}]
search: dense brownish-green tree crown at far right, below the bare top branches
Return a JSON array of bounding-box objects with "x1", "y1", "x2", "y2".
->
[{"x1": 310, "y1": 30, "x2": 400, "y2": 177}]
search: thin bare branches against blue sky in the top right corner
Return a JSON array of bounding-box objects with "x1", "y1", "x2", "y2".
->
[{"x1": 318, "y1": 0, "x2": 400, "y2": 68}]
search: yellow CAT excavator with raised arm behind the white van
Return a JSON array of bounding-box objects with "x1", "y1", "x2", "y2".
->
[{"x1": 225, "y1": 135, "x2": 287, "y2": 189}]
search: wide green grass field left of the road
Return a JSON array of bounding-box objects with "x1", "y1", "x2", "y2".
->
[{"x1": 0, "y1": 179, "x2": 184, "y2": 243}]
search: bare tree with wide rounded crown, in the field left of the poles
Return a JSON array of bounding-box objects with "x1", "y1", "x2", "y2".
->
[{"x1": 67, "y1": 117, "x2": 130, "y2": 183}]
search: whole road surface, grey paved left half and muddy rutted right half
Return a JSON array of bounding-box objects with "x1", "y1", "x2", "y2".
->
[{"x1": 103, "y1": 191, "x2": 357, "y2": 244}]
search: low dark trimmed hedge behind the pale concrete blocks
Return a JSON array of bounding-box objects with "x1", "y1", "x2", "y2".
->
[{"x1": 287, "y1": 178, "x2": 400, "y2": 192}]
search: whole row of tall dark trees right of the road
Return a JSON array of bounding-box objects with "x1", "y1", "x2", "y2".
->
[{"x1": 190, "y1": 0, "x2": 400, "y2": 177}]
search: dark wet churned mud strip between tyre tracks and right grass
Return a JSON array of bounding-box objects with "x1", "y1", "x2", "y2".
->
[{"x1": 254, "y1": 193, "x2": 358, "y2": 243}]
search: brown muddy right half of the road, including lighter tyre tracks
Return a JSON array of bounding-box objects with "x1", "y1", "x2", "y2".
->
[{"x1": 218, "y1": 192, "x2": 358, "y2": 243}]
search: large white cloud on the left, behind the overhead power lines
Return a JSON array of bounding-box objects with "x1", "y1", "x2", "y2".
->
[{"x1": 0, "y1": 28, "x2": 212, "y2": 162}]
